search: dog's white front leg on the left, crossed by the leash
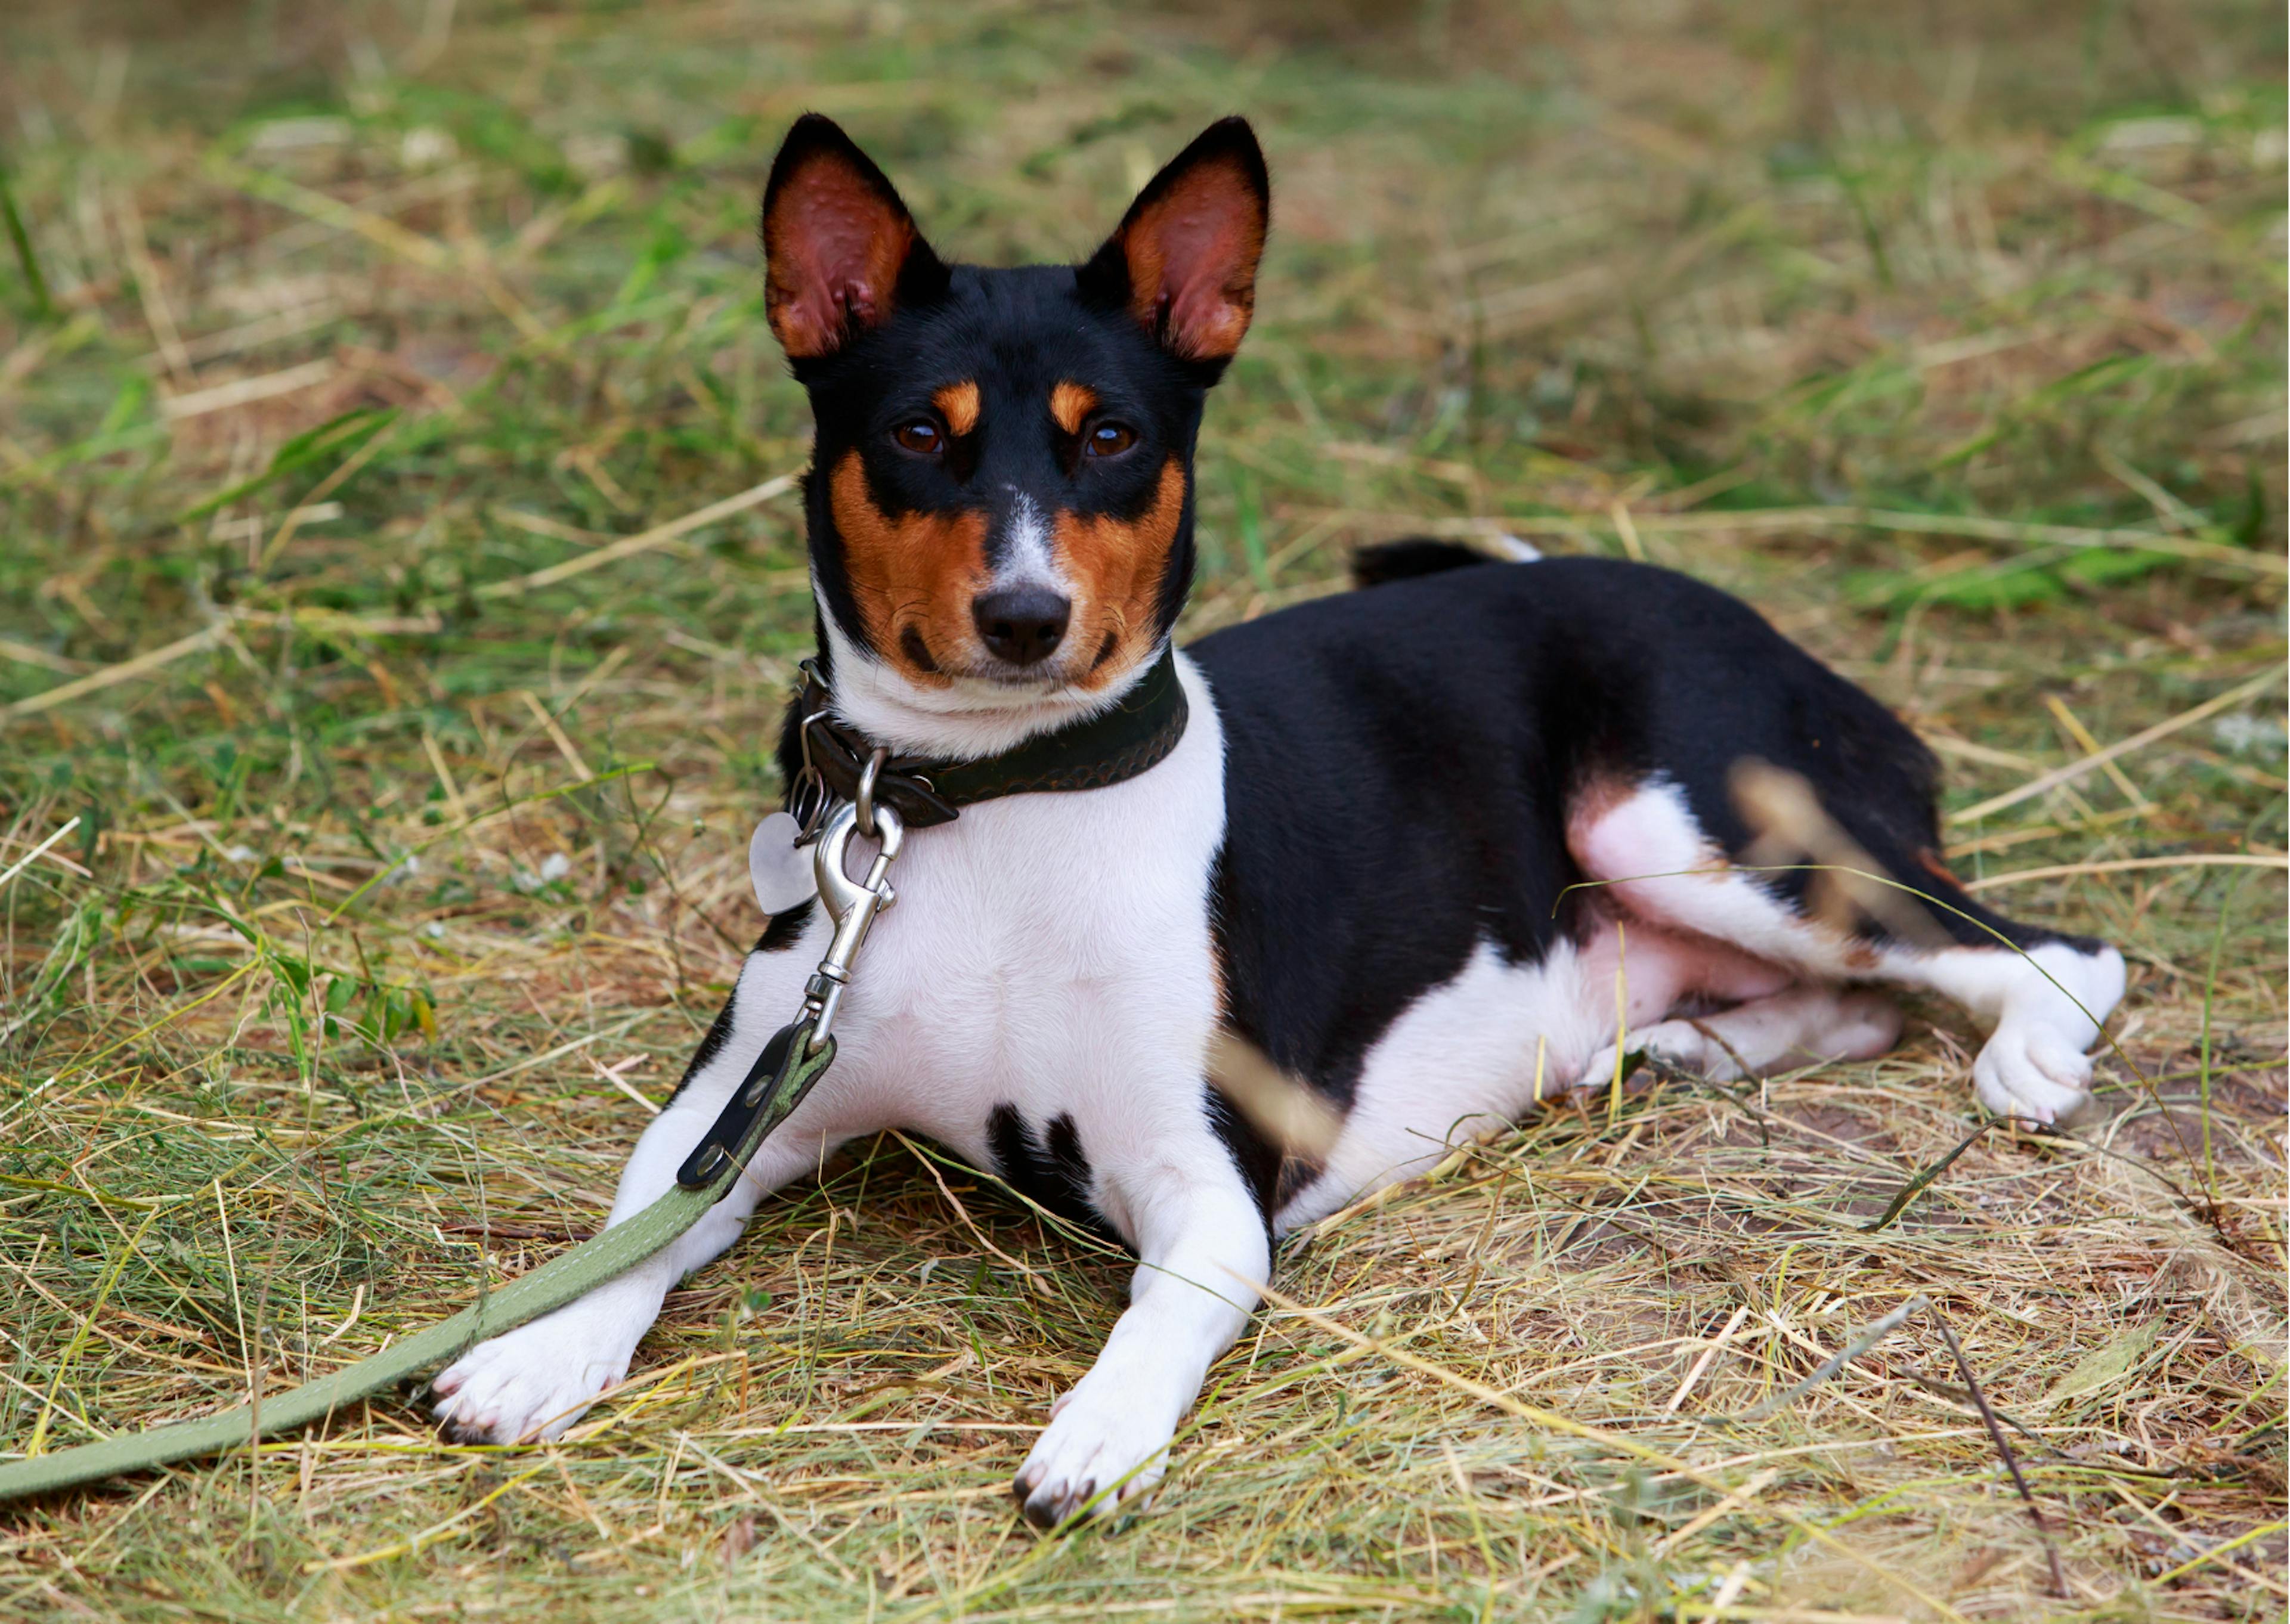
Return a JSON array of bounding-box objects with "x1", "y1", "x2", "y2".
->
[{"x1": 433, "y1": 950, "x2": 845, "y2": 1443}]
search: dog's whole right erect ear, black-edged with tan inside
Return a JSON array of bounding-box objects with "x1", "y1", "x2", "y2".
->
[{"x1": 1081, "y1": 119, "x2": 1271, "y2": 362}]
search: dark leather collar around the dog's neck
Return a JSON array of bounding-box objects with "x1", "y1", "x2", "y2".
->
[{"x1": 788, "y1": 646, "x2": 1186, "y2": 829}]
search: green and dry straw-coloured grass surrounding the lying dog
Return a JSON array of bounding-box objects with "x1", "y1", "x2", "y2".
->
[{"x1": 0, "y1": 0, "x2": 2285, "y2": 1622}]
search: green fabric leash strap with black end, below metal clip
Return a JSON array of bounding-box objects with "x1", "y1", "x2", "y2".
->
[{"x1": 0, "y1": 1037, "x2": 836, "y2": 1501}]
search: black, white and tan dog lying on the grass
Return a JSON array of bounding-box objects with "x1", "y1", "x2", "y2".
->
[{"x1": 435, "y1": 114, "x2": 2123, "y2": 1526}]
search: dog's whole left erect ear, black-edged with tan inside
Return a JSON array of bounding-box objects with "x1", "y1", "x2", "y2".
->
[{"x1": 763, "y1": 112, "x2": 946, "y2": 362}]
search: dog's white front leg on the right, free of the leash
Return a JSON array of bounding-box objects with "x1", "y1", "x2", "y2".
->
[{"x1": 1012, "y1": 1159, "x2": 1271, "y2": 1528}]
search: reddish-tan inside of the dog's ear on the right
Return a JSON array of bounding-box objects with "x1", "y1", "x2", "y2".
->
[{"x1": 1122, "y1": 163, "x2": 1264, "y2": 359}]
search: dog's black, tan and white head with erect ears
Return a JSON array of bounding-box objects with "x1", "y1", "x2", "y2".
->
[{"x1": 763, "y1": 114, "x2": 1271, "y2": 751}]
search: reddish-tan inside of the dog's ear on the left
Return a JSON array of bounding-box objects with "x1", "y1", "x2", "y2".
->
[{"x1": 763, "y1": 153, "x2": 914, "y2": 359}]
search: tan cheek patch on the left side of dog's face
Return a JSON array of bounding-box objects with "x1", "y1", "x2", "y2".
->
[{"x1": 829, "y1": 451, "x2": 987, "y2": 687}]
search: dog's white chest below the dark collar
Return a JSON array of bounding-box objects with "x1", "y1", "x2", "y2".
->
[{"x1": 794, "y1": 662, "x2": 1223, "y2": 1159}]
